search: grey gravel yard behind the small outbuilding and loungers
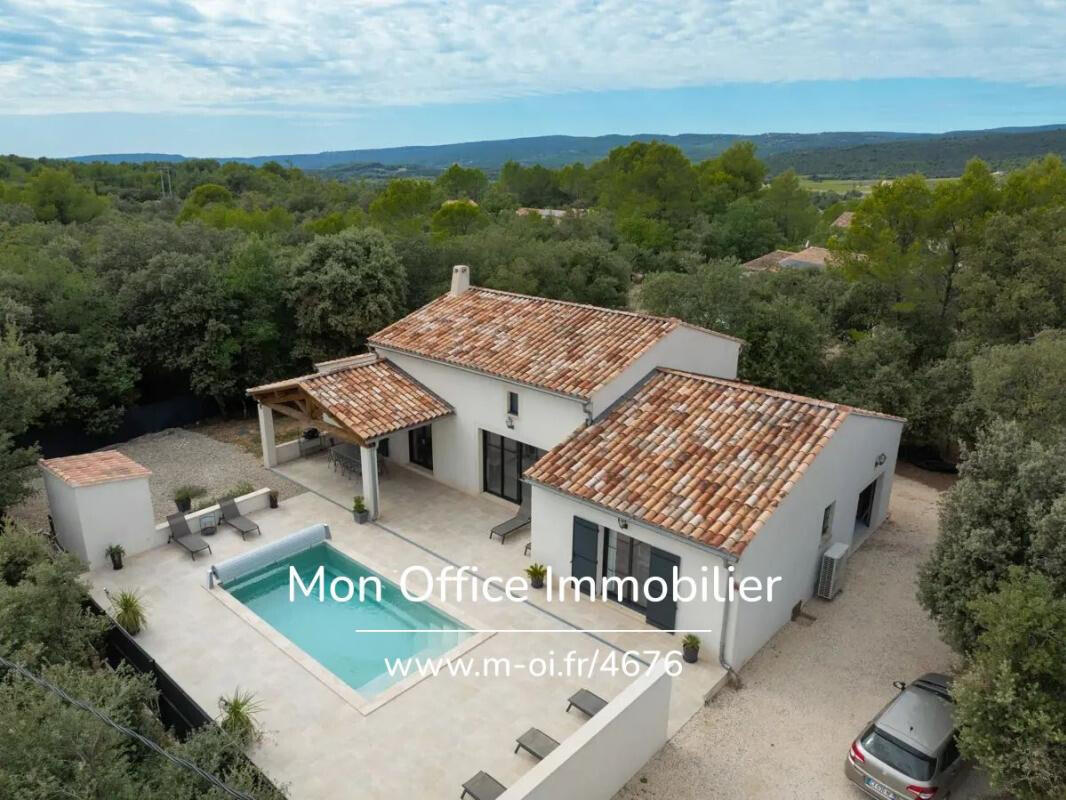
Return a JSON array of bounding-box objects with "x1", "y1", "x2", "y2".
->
[{"x1": 12, "y1": 428, "x2": 306, "y2": 528}]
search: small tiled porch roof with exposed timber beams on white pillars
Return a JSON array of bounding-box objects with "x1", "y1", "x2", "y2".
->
[{"x1": 248, "y1": 353, "x2": 454, "y2": 444}]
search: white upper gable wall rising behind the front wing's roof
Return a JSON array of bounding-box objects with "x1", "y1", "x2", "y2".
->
[{"x1": 592, "y1": 325, "x2": 741, "y2": 416}]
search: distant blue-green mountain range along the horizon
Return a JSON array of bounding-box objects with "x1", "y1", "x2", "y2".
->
[{"x1": 70, "y1": 125, "x2": 1066, "y2": 178}]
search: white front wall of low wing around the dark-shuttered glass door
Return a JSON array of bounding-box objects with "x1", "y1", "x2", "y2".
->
[{"x1": 527, "y1": 484, "x2": 727, "y2": 658}]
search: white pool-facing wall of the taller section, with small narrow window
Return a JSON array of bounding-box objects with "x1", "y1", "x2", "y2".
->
[{"x1": 370, "y1": 349, "x2": 585, "y2": 494}]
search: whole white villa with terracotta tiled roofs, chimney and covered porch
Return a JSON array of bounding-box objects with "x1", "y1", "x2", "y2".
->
[{"x1": 248, "y1": 266, "x2": 903, "y2": 667}]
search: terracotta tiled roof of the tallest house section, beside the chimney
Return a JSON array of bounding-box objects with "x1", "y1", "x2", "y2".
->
[{"x1": 368, "y1": 287, "x2": 740, "y2": 400}]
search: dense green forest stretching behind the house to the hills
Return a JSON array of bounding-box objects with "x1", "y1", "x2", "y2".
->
[{"x1": 0, "y1": 142, "x2": 1066, "y2": 520}]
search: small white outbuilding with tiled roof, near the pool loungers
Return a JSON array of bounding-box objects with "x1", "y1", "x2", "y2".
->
[{"x1": 37, "y1": 450, "x2": 159, "y2": 569}]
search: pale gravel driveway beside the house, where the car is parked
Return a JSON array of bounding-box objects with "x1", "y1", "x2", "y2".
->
[{"x1": 616, "y1": 467, "x2": 983, "y2": 800}]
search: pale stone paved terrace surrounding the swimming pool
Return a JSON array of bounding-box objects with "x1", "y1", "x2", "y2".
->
[{"x1": 90, "y1": 458, "x2": 724, "y2": 800}]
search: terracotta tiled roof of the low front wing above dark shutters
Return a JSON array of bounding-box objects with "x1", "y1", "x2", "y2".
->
[{"x1": 526, "y1": 369, "x2": 898, "y2": 556}]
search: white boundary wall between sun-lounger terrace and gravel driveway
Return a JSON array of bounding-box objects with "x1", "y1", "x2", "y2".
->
[{"x1": 500, "y1": 661, "x2": 671, "y2": 800}]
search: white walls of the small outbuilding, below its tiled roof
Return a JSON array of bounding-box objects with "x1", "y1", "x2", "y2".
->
[{"x1": 44, "y1": 470, "x2": 159, "y2": 569}]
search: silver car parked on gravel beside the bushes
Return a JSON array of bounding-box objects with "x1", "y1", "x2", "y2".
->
[{"x1": 844, "y1": 672, "x2": 963, "y2": 800}]
